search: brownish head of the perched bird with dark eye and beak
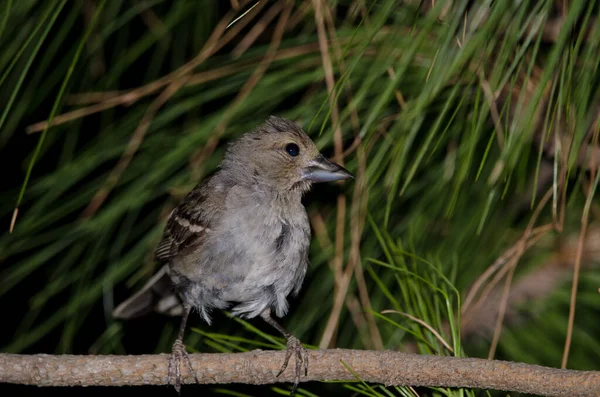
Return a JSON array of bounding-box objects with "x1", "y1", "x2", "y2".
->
[{"x1": 221, "y1": 116, "x2": 352, "y2": 193}]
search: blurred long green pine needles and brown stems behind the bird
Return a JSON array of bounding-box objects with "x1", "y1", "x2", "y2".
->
[{"x1": 0, "y1": 0, "x2": 600, "y2": 396}]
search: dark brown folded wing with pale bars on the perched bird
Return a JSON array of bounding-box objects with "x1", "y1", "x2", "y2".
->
[{"x1": 155, "y1": 180, "x2": 216, "y2": 261}]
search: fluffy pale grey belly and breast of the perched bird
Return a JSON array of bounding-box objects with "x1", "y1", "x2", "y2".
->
[{"x1": 177, "y1": 210, "x2": 310, "y2": 318}]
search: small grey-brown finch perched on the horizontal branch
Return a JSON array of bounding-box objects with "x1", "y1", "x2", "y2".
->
[{"x1": 113, "y1": 116, "x2": 353, "y2": 395}]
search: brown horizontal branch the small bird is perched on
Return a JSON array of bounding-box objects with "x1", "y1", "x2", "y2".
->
[{"x1": 0, "y1": 349, "x2": 600, "y2": 396}]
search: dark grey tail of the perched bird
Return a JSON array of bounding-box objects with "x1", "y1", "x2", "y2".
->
[{"x1": 112, "y1": 265, "x2": 183, "y2": 319}]
